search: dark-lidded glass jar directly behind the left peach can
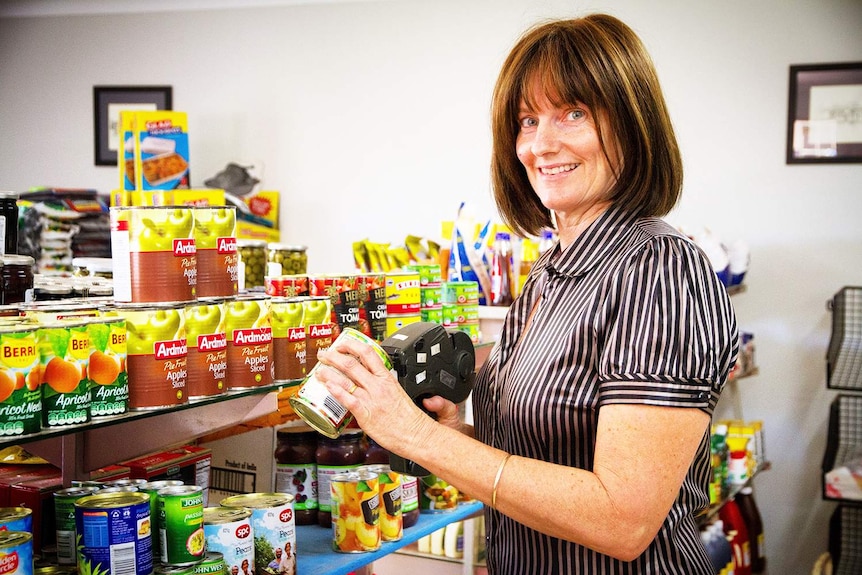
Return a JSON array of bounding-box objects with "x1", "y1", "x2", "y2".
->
[{"x1": 315, "y1": 429, "x2": 365, "y2": 528}]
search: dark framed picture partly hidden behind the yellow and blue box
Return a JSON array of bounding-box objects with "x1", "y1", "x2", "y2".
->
[{"x1": 93, "y1": 86, "x2": 173, "y2": 166}]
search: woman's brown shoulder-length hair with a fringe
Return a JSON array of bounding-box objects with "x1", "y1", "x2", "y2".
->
[{"x1": 491, "y1": 14, "x2": 682, "y2": 235}]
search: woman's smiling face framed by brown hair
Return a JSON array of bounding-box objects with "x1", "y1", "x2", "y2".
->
[{"x1": 516, "y1": 83, "x2": 616, "y2": 223}]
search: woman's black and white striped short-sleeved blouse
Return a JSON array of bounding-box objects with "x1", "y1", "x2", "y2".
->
[{"x1": 473, "y1": 208, "x2": 738, "y2": 575}]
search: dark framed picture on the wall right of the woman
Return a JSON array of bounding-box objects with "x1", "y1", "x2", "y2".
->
[{"x1": 787, "y1": 62, "x2": 862, "y2": 164}]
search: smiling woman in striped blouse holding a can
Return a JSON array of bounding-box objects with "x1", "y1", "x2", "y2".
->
[{"x1": 320, "y1": 15, "x2": 738, "y2": 575}]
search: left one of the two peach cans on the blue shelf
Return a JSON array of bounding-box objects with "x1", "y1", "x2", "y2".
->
[{"x1": 329, "y1": 470, "x2": 380, "y2": 553}]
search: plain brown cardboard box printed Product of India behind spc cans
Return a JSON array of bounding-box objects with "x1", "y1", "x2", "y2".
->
[{"x1": 201, "y1": 427, "x2": 275, "y2": 505}]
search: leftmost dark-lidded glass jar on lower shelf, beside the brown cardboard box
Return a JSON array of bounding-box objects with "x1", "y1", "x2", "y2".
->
[{"x1": 275, "y1": 426, "x2": 319, "y2": 525}]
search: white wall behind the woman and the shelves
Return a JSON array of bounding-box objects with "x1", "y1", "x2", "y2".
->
[{"x1": 0, "y1": 0, "x2": 862, "y2": 574}]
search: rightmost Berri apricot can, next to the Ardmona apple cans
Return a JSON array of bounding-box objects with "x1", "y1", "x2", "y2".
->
[{"x1": 87, "y1": 317, "x2": 129, "y2": 419}]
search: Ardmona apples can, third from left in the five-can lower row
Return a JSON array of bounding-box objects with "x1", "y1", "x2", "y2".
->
[{"x1": 225, "y1": 295, "x2": 275, "y2": 389}]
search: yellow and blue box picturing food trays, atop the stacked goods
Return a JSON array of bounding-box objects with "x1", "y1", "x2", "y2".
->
[{"x1": 117, "y1": 110, "x2": 190, "y2": 190}]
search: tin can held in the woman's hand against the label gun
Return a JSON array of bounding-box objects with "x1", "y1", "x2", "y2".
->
[{"x1": 289, "y1": 328, "x2": 392, "y2": 438}]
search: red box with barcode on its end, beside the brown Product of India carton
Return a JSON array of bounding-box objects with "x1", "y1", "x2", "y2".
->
[{"x1": 120, "y1": 445, "x2": 212, "y2": 504}]
